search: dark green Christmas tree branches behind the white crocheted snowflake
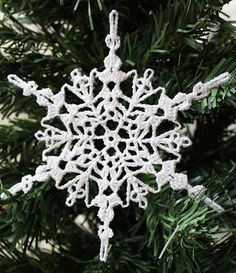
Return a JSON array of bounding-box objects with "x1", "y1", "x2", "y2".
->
[{"x1": 0, "y1": 0, "x2": 236, "y2": 273}]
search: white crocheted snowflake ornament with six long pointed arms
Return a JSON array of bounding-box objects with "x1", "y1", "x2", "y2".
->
[{"x1": 2, "y1": 11, "x2": 229, "y2": 261}]
